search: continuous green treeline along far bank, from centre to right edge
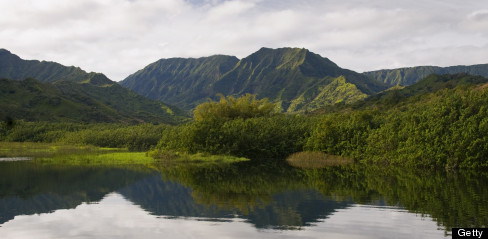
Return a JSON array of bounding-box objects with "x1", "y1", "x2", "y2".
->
[{"x1": 153, "y1": 77, "x2": 488, "y2": 168}]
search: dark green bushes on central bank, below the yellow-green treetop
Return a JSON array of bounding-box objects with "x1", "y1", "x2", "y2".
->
[{"x1": 156, "y1": 115, "x2": 311, "y2": 159}]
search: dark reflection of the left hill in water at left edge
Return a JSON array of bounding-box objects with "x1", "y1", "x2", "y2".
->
[{"x1": 0, "y1": 162, "x2": 150, "y2": 225}]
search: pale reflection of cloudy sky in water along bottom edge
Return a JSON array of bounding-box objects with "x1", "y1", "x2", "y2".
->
[{"x1": 0, "y1": 193, "x2": 443, "y2": 239}]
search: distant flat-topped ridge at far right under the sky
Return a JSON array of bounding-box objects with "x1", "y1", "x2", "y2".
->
[{"x1": 363, "y1": 64, "x2": 488, "y2": 86}]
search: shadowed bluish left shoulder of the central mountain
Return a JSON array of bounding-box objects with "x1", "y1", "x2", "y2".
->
[{"x1": 120, "y1": 55, "x2": 239, "y2": 110}]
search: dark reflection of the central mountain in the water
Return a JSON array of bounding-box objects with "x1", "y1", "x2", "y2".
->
[{"x1": 118, "y1": 176, "x2": 351, "y2": 229}]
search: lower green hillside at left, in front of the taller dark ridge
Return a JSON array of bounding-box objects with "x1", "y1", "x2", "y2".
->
[{"x1": 0, "y1": 78, "x2": 187, "y2": 124}]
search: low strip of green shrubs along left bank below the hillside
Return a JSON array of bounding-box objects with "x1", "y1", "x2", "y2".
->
[{"x1": 0, "y1": 119, "x2": 169, "y2": 151}]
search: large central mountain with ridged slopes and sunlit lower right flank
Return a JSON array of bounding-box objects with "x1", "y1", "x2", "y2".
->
[{"x1": 120, "y1": 48, "x2": 387, "y2": 112}]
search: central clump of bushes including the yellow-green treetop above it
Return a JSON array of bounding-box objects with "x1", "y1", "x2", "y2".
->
[{"x1": 152, "y1": 95, "x2": 309, "y2": 158}]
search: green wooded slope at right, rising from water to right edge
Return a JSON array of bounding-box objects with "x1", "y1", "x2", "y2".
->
[{"x1": 306, "y1": 74, "x2": 488, "y2": 168}]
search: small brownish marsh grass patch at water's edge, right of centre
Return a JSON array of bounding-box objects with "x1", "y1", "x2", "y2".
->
[{"x1": 286, "y1": 152, "x2": 354, "y2": 168}]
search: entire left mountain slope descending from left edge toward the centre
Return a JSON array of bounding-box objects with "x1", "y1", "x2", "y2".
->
[{"x1": 0, "y1": 50, "x2": 186, "y2": 124}]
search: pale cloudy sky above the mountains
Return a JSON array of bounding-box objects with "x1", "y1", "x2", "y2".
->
[{"x1": 0, "y1": 0, "x2": 488, "y2": 81}]
